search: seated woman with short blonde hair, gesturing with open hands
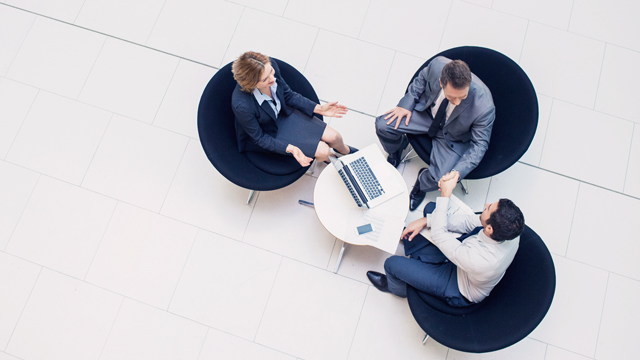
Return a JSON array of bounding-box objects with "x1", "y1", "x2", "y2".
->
[{"x1": 231, "y1": 51, "x2": 358, "y2": 166}]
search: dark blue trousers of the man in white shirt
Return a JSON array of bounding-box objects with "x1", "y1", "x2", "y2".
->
[{"x1": 384, "y1": 234, "x2": 471, "y2": 307}]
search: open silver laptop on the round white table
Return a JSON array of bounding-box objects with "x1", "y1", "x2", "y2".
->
[{"x1": 330, "y1": 144, "x2": 405, "y2": 209}]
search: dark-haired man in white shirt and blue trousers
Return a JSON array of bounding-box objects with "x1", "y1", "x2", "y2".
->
[{"x1": 367, "y1": 171, "x2": 524, "y2": 307}]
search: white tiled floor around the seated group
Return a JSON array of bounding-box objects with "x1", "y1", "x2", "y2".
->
[{"x1": 0, "y1": 0, "x2": 640, "y2": 360}]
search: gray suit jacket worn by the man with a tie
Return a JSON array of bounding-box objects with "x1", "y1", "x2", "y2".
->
[{"x1": 398, "y1": 56, "x2": 496, "y2": 179}]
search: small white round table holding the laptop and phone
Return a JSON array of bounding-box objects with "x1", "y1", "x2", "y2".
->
[{"x1": 313, "y1": 163, "x2": 409, "y2": 272}]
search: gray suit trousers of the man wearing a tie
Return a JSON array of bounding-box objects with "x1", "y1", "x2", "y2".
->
[{"x1": 376, "y1": 110, "x2": 461, "y2": 192}]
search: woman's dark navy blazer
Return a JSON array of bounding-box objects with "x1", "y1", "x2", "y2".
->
[{"x1": 231, "y1": 58, "x2": 316, "y2": 154}]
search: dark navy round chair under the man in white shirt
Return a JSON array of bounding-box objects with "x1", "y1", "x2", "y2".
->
[{"x1": 407, "y1": 226, "x2": 556, "y2": 353}]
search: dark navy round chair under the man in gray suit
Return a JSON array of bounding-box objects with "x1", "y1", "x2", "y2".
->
[{"x1": 405, "y1": 46, "x2": 538, "y2": 179}]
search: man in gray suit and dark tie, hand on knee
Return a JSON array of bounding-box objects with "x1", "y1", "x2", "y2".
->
[{"x1": 376, "y1": 56, "x2": 495, "y2": 211}]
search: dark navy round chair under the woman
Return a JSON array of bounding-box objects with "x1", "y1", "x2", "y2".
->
[{"x1": 198, "y1": 59, "x2": 322, "y2": 191}]
